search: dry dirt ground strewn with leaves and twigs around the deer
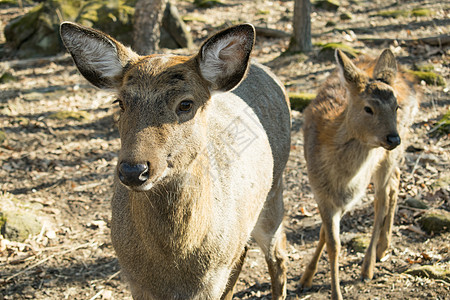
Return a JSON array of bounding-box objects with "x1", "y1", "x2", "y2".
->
[{"x1": 0, "y1": 0, "x2": 450, "y2": 299}]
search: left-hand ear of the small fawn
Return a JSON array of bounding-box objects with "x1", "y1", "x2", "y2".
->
[{"x1": 335, "y1": 49, "x2": 368, "y2": 92}]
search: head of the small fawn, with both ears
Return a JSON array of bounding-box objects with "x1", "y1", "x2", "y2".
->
[{"x1": 336, "y1": 49, "x2": 400, "y2": 150}]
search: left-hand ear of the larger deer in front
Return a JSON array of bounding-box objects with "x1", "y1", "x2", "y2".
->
[{"x1": 60, "y1": 22, "x2": 138, "y2": 89}]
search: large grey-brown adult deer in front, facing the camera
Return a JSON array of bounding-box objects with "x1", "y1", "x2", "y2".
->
[{"x1": 61, "y1": 22, "x2": 290, "y2": 300}]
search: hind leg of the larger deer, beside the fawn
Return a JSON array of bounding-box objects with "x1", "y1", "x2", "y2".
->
[{"x1": 252, "y1": 176, "x2": 287, "y2": 299}]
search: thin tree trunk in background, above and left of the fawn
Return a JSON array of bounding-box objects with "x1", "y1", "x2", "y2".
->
[{"x1": 289, "y1": 0, "x2": 312, "y2": 52}]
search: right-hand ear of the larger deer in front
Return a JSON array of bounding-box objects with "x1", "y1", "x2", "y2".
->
[{"x1": 197, "y1": 24, "x2": 255, "y2": 91}]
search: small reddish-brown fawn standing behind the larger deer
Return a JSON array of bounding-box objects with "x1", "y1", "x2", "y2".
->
[{"x1": 300, "y1": 50, "x2": 417, "y2": 299}]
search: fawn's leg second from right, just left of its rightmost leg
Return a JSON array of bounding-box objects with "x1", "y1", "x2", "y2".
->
[{"x1": 361, "y1": 155, "x2": 395, "y2": 280}]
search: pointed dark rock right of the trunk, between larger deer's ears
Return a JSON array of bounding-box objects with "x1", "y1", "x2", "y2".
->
[{"x1": 159, "y1": 2, "x2": 193, "y2": 49}]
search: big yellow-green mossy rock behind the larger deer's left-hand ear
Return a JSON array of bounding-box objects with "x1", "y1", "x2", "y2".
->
[{"x1": 5, "y1": 0, "x2": 136, "y2": 58}]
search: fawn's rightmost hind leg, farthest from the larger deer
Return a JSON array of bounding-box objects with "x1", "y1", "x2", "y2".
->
[{"x1": 376, "y1": 167, "x2": 400, "y2": 260}]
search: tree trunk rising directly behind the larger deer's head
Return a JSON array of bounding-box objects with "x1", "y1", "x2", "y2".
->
[{"x1": 133, "y1": 0, "x2": 167, "y2": 55}]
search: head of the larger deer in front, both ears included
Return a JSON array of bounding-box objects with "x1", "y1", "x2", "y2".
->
[{"x1": 61, "y1": 22, "x2": 255, "y2": 191}]
